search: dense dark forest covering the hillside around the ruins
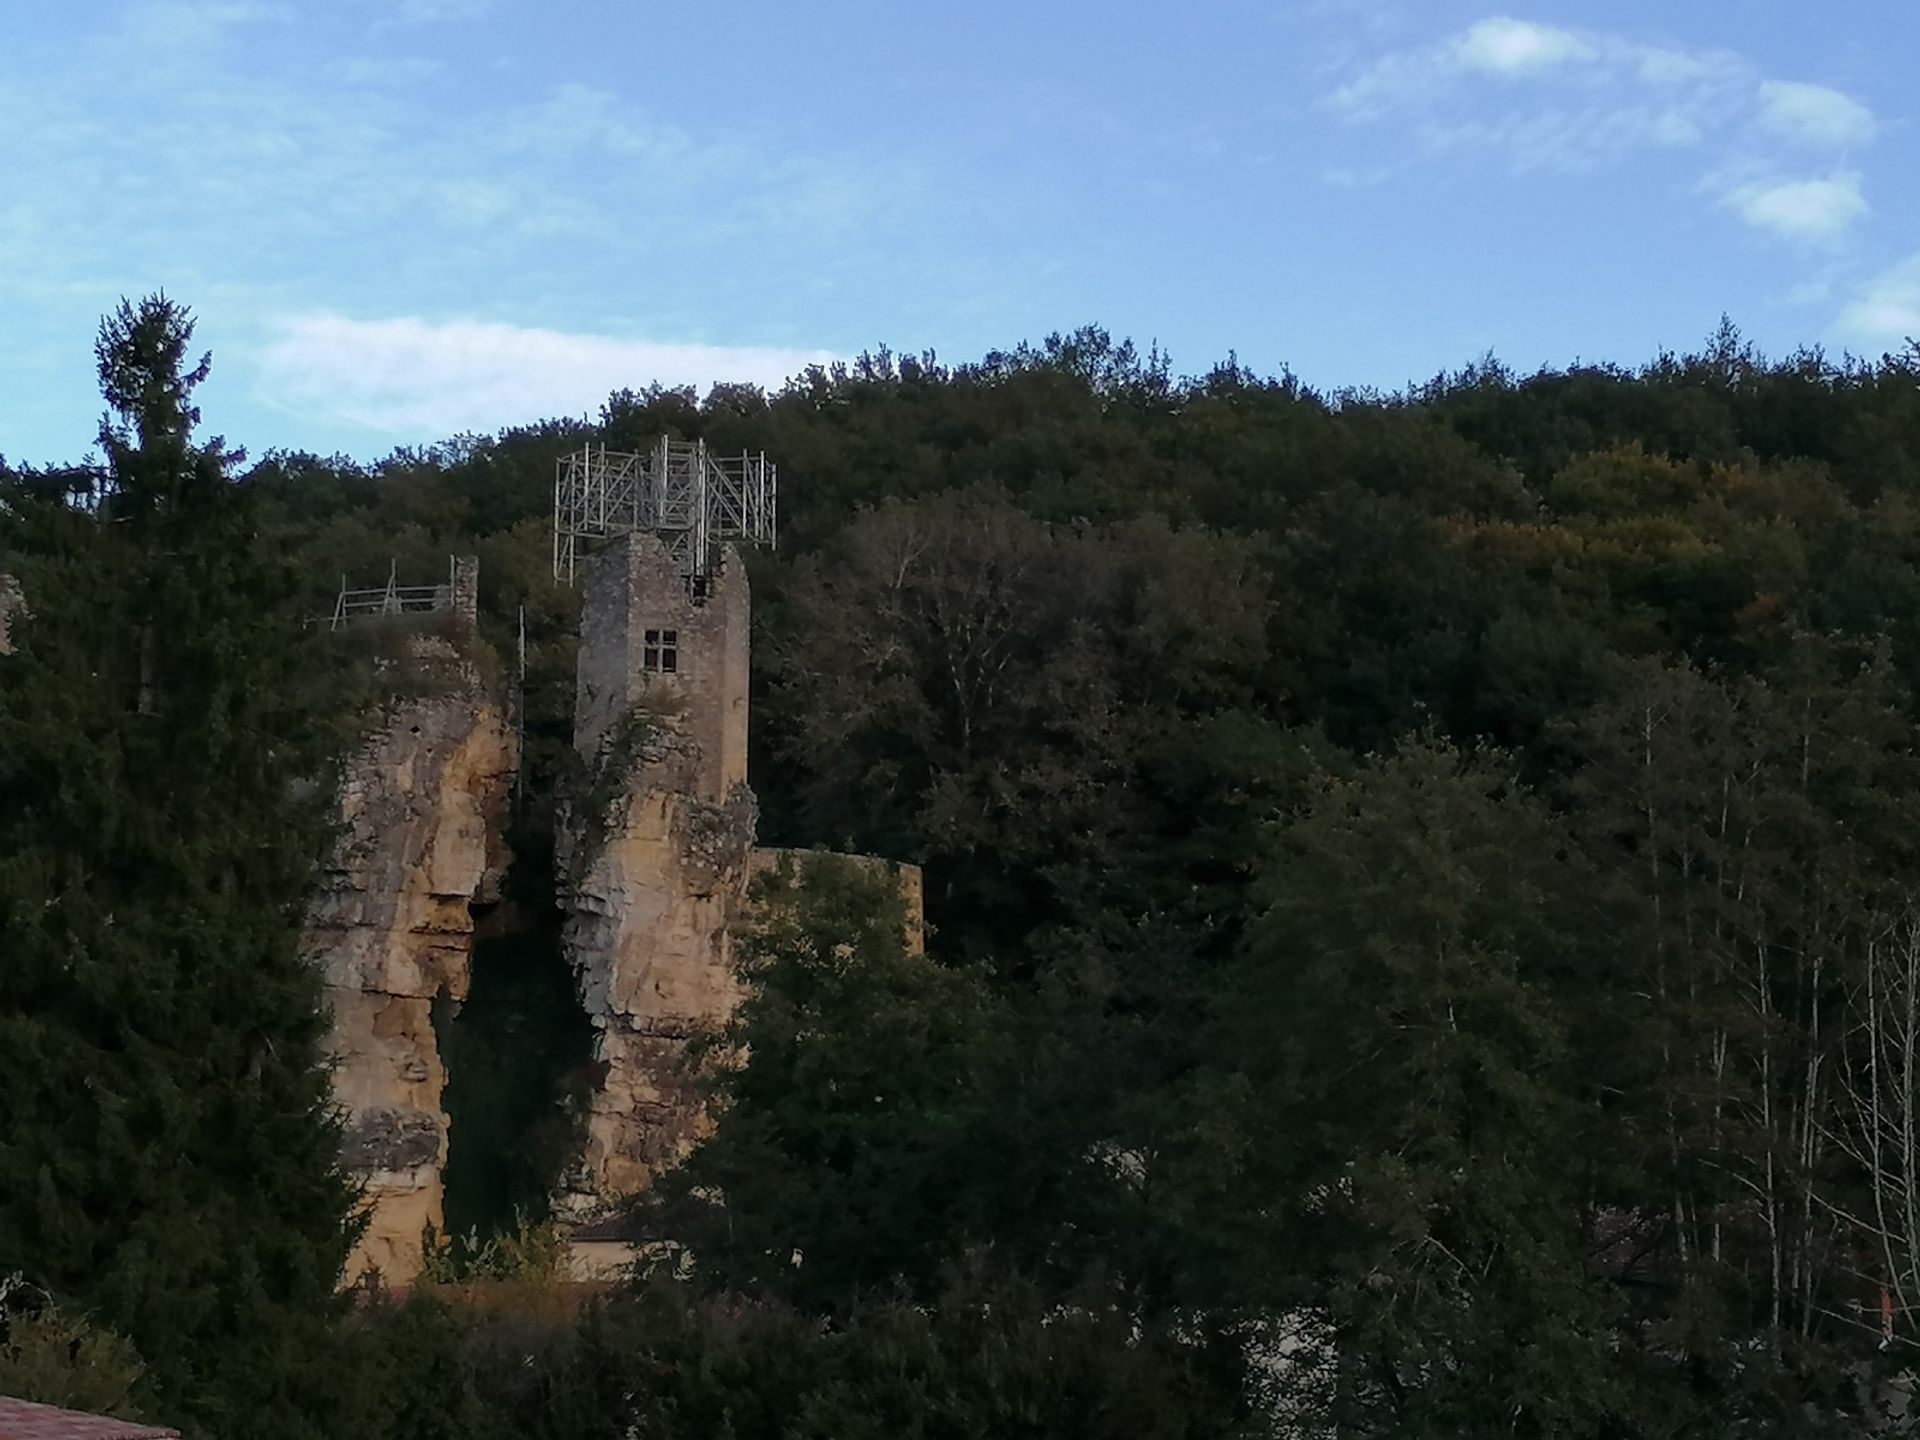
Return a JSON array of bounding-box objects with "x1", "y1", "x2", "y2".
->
[{"x1": 0, "y1": 311, "x2": 1920, "y2": 1436}]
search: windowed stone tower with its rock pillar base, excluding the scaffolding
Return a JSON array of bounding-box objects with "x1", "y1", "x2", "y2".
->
[{"x1": 563, "y1": 532, "x2": 755, "y2": 1217}]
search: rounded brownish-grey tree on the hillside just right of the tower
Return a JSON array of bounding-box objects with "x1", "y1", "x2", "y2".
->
[{"x1": 762, "y1": 490, "x2": 1267, "y2": 975}]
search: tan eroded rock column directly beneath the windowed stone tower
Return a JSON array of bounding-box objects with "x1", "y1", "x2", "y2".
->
[{"x1": 559, "y1": 724, "x2": 755, "y2": 1219}]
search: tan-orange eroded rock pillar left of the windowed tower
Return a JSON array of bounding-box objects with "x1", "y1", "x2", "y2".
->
[{"x1": 307, "y1": 649, "x2": 516, "y2": 1284}]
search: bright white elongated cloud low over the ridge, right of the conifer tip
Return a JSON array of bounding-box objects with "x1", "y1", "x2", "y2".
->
[{"x1": 257, "y1": 311, "x2": 835, "y2": 440}]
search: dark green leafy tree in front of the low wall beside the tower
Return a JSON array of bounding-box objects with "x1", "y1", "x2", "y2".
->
[{"x1": 645, "y1": 860, "x2": 996, "y2": 1308}]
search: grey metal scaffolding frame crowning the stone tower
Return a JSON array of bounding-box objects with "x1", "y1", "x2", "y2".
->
[{"x1": 553, "y1": 436, "x2": 780, "y2": 584}]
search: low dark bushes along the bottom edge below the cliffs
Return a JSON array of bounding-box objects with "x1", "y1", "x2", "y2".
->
[{"x1": 339, "y1": 1258, "x2": 1258, "y2": 1440}]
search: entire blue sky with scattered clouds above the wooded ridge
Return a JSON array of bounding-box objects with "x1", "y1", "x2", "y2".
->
[{"x1": 0, "y1": 0, "x2": 1920, "y2": 463}]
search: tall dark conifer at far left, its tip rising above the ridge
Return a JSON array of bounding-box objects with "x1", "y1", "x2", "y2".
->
[{"x1": 0, "y1": 296, "x2": 351, "y2": 1436}]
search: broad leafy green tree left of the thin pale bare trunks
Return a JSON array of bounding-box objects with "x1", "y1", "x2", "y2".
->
[{"x1": 1198, "y1": 741, "x2": 1632, "y2": 1436}]
